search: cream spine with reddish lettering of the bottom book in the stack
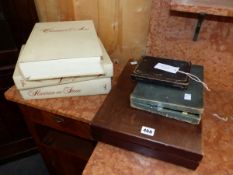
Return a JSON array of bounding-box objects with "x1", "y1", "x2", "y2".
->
[{"x1": 19, "y1": 78, "x2": 111, "y2": 100}]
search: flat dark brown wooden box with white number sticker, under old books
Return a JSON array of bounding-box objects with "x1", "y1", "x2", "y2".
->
[{"x1": 91, "y1": 60, "x2": 203, "y2": 169}]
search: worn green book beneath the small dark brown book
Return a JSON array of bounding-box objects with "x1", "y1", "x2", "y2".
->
[{"x1": 130, "y1": 65, "x2": 204, "y2": 124}]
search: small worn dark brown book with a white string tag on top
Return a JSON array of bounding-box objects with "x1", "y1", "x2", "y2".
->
[{"x1": 131, "y1": 56, "x2": 191, "y2": 89}]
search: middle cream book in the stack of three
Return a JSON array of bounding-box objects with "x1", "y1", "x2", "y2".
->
[{"x1": 13, "y1": 40, "x2": 113, "y2": 90}]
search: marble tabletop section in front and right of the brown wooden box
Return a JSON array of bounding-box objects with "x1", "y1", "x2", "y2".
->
[{"x1": 83, "y1": 91, "x2": 233, "y2": 175}]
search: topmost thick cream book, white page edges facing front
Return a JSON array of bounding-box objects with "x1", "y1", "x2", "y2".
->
[{"x1": 18, "y1": 20, "x2": 104, "y2": 80}]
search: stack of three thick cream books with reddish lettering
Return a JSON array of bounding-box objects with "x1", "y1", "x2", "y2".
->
[{"x1": 13, "y1": 20, "x2": 113, "y2": 99}]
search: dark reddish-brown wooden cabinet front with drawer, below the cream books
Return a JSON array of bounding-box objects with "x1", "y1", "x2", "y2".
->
[{"x1": 19, "y1": 104, "x2": 96, "y2": 175}]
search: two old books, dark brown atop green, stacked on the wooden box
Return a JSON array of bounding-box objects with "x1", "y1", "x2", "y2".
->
[{"x1": 130, "y1": 57, "x2": 204, "y2": 124}]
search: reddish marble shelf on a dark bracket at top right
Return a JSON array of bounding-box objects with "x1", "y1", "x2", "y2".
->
[{"x1": 171, "y1": 0, "x2": 233, "y2": 17}]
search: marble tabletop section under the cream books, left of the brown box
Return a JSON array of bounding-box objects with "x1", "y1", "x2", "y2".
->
[{"x1": 5, "y1": 64, "x2": 123, "y2": 123}]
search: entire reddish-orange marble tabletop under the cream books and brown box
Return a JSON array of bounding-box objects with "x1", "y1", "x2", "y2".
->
[{"x1": 5, "y1": 60, "x2": 233, "y2": 175}]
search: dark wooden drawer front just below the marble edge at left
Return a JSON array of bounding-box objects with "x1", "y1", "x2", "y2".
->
[{"x1": 20, "y1": 105, "x2": 93, "y2": 140}]
